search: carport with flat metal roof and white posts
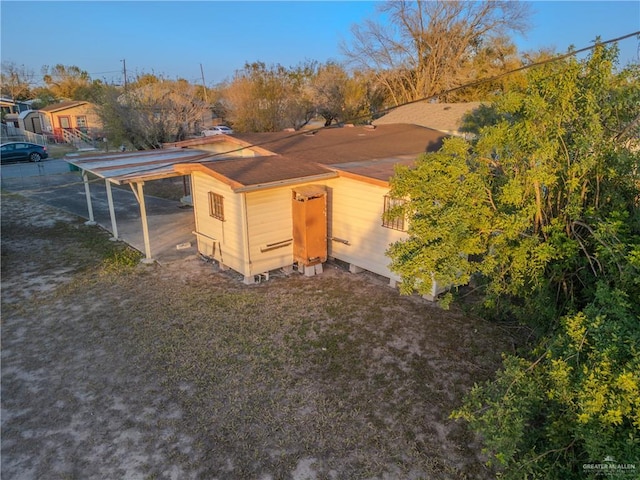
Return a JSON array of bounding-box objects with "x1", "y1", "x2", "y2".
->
[{"x1": 65, "y1": 148, "x2": 212, "y2": 263}]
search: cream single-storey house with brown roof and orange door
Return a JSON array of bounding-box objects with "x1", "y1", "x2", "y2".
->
[{"x1": 168, "y1": 124, "x2": 445, "y2": 297}]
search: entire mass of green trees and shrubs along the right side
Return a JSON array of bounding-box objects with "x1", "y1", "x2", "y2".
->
[{"x1": 389, "y1": 45, "x2": 640, "y2": 479}]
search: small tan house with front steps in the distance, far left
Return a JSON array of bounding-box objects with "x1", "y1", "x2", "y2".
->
[{"x1": 39, "y1": 101, "x2": 102, "y2": 143}]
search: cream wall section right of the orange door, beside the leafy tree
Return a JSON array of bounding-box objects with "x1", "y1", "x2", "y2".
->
[{"x1": 329, "y1": 177, "x2": 407, "y2": 280}]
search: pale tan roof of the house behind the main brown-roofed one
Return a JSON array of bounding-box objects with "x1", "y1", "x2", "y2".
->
[{"x1": 373, "y1": 101, "x2": 482, "y2": 136}]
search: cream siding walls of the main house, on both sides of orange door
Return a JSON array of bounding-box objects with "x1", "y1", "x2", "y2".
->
[{"x1": 192, "y1": 172, "x2": 406, "y2": 280}]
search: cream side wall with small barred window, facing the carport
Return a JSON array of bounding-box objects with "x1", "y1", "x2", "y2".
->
[{"x1": 191, "y1": 172, "x2": 249, "y2": 275}]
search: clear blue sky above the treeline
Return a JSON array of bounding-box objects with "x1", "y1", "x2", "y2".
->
[{"x1": 0, "y1": 0, "x2": 640, "y2": 86}]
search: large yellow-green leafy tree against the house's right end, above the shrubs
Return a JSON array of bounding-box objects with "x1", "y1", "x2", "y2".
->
[{"x1": 390, "y1": 44, "x2": 640, "y2": 314}]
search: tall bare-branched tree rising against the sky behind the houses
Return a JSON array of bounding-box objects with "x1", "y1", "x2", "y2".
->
[{"x1": 343, "y1": 0, "x2": 528, "y2": 105}]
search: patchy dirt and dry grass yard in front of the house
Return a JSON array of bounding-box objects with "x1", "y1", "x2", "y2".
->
[{"x1": 1, "y1": 194, "x2": 511, "y2": 480}]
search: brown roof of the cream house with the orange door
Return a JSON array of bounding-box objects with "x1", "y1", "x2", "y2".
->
[{"x1": 179, "y1": 125, "x2": 445, "y2": 189}]
